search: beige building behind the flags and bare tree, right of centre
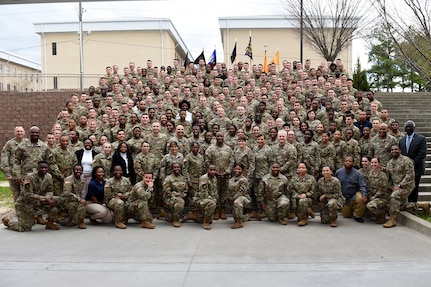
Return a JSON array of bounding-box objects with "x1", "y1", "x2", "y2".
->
[{"x1": 219, "y1": 15, "x2": 352, "y2": 75}]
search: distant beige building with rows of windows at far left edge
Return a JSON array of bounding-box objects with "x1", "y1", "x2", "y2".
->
[{"x1": 0, "y1": 50, "x2": 42, "y2": 92}]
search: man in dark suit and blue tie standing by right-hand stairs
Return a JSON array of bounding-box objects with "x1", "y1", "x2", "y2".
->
[{"x1": 399, "y1": 120, "x2": 430, "y2": 209}]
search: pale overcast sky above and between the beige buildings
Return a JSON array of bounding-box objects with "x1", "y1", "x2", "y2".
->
[{"x1": 0, "y1": 0, "x2": 367, "y2": 66}]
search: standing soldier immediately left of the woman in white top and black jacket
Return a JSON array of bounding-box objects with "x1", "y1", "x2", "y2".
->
[{"x1": 49, "y1": 136, "x2": 78, "y2": 196}]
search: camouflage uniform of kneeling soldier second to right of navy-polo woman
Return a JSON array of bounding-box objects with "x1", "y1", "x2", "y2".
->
[{"x1": 126, "y1": 181, "x2": 154, "y2": 222}]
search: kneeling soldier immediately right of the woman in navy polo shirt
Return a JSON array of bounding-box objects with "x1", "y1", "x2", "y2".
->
[{"x1": 105, "y1": 165, "x2": 132, "y2": 229}]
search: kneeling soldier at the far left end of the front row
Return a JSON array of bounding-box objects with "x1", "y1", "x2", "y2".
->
[{"x1": 2, "y1": 161, "x2": 60, "y2": 232}]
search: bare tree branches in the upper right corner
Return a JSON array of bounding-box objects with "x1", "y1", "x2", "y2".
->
[{"x1": 371, "y1": 0, "x2": 431, "y2": 88}]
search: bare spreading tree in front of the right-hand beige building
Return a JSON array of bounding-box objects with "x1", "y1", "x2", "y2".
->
[{"x1": 281, "y1": 0, "x2": 367, "y2": 62}]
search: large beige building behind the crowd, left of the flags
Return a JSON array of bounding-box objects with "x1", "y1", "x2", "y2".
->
[{"x1": 34, "y1": 18, "x2": 192, "y2": 90}]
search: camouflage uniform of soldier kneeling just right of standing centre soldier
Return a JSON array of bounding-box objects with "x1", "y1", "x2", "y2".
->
[{"x1": 229, "y1": 175, "x2": 251, "y2": 221}]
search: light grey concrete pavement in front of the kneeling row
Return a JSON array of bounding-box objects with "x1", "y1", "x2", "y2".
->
[{"x1": 0, "y1": 217, "x2": 431, "y2": 287}]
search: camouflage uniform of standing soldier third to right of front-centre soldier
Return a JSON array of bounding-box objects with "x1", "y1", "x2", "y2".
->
[{"x1": 272, "y1": 142, "x2": 298, "y2": 179}]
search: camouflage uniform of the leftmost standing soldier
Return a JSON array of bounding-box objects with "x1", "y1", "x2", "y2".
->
[{"x1": 1, "y1": 138, "x2": 28, "y2": 201}]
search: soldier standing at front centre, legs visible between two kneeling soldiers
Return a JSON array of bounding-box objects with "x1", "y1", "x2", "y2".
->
[{"x1": 205, "y1": 132, "x2": 234, "y2": 220}]
